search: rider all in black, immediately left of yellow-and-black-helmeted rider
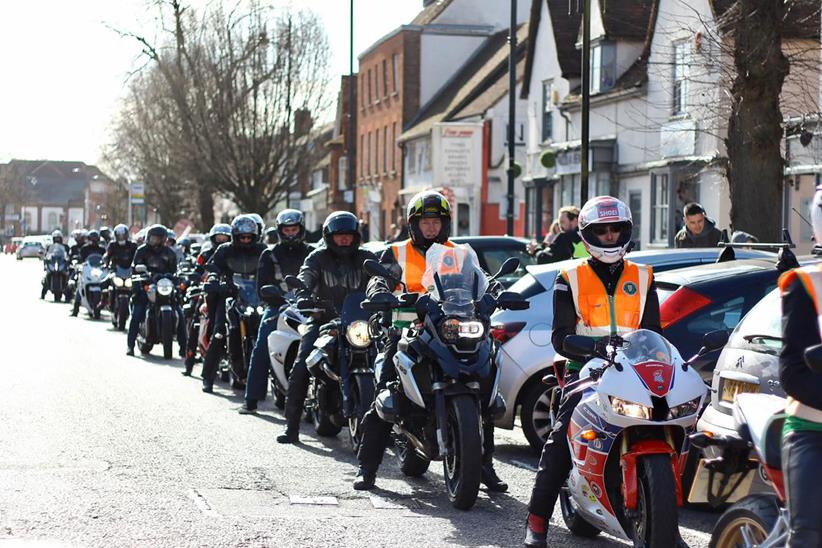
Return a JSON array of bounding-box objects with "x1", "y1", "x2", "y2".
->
[{"x1": 277, "y1": 211, "x2": 377, "y2": 443}]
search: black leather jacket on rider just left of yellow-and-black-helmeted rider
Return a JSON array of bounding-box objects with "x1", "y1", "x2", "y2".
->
[{"x1": 297, "y1": 248, "x2": 377, "y2": 310}]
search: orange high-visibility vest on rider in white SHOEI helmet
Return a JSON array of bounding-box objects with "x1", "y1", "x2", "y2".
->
[{"x1": 562, "y1": 261, "x2": 653, "y2": 337}]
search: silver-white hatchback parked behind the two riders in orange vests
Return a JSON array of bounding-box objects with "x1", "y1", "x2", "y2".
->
[{"x1": 491, "y1": 248, "x2": 775, "y2": 452}]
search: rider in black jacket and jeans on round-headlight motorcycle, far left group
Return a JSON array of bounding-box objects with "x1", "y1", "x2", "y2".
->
[{"x1": 126, "y1": 224, "x2": 186, "y2": 356}]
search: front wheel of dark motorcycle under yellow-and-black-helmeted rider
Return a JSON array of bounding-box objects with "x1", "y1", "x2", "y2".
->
[{"x1": 443, "y1": 394, "x2": 482, "y2": 510}]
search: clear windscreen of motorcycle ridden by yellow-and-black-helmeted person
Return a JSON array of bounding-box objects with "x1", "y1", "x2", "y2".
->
[{"x1": 422, "y1": 244, "x2": 488, "y2": 316}]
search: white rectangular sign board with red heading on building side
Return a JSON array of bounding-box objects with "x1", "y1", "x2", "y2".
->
[{"x1": 431, "y1": 122, "x2": 482, "y2": 188}]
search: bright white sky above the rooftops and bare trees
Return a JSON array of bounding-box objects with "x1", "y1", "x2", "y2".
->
[{"x1": 0, "y1": 0, "x2": 422, "y2": 163}]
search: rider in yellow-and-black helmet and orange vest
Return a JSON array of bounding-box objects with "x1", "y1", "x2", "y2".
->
[{"x1": 354, "y1": 191, "x2": 508, "y2": 492}]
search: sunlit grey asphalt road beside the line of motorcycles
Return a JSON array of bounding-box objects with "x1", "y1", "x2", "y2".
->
[{"x1": 0, "y1": 255, "x2": 717, "y2": 547}]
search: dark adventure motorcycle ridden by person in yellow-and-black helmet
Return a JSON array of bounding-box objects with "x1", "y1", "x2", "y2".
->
[{"x1": 362, "y1": 248, "x2": 528, "y2": 510}]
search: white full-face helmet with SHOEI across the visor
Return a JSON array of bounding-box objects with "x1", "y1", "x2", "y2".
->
[{"x1": 579, "y1": 196, "x2": 634, "y2": 264}]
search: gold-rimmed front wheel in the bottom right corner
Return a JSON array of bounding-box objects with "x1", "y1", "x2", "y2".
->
[{"x1": 709, "y1": 495, "x2": 780, "y2": 548}]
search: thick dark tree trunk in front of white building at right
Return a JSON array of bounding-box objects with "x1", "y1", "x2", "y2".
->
[{"x1": 725, "y1": 0, "x2": 790, "y2": 242}]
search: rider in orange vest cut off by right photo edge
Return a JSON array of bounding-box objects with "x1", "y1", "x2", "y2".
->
[{"x1": 779, "y1": 185, "x2": 822, "y2": 548}]
